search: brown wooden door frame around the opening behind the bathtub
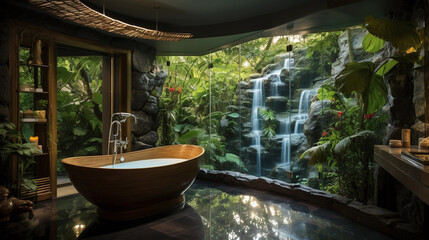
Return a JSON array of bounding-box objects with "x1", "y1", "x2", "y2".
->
[{"x1": 9, "y1": 21, "x2": 131, "y2": 198}]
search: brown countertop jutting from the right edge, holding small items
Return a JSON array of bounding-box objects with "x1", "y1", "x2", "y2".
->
[{"x1": 374, "y1": 145, "x2": 429, "y2": 205}]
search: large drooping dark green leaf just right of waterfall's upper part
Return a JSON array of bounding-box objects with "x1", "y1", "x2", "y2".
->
[{"x1": 335, "y1": 62, "x2": 387, "y2": 113}]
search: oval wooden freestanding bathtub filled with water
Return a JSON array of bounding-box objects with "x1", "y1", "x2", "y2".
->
[{"x1": 62, "y1": 145, "x2": 204, "y2": 221}]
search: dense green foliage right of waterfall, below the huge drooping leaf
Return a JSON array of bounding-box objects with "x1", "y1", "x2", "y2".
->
[{"x1": 301, "y1": 82, "x2": 387, "y2": 203}]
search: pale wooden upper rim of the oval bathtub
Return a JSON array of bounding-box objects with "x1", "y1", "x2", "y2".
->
[{"x1": 61, "y1": 144, "x2": 205, "y2": 171}]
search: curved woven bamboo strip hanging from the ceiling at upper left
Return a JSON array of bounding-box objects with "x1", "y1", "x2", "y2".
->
[{"x1": 30, "y1": 0, "x2": 192, "y2": 41}]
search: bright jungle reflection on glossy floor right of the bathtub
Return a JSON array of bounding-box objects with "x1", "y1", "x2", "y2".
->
[{"x1": 187, "y1": 182, "x2": 390, "y2": 240}]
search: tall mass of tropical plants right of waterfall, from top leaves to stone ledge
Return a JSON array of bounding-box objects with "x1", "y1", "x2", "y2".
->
[{"x1": 301, "y1": 17, "x2": 423, "y2": 203}]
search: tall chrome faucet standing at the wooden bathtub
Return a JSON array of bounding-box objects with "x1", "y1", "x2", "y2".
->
[{"x1": 107, "y1": 112, "x2": 137, "y2": 166}]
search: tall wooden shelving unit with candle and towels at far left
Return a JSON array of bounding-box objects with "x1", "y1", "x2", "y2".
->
[{"x1": 10, "y1": 28, "x2": 57, "y2": 202}]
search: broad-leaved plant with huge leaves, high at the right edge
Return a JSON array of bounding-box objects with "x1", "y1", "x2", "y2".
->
[{"x1": 335, "y1": 17, "x2": 423, "y2": 114}]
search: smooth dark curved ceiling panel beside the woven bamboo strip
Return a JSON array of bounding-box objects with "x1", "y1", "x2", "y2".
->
[{"x1": 10, "y1": 0, "x2": 405, "y2": 55}]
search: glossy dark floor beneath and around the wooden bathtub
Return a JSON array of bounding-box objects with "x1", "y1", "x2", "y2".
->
[{"x1": 0, "y1": 181, "x2": 390, "y2": 240}]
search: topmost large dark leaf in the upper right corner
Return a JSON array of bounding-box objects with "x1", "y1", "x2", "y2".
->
[{"x1": 365, "y1": 16, "x2": 421, "y2": 52}]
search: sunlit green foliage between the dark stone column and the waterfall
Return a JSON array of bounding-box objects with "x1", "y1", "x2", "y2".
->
[{"x1": 158, "y1": 48, "x2": 245, "y2": 171}]
